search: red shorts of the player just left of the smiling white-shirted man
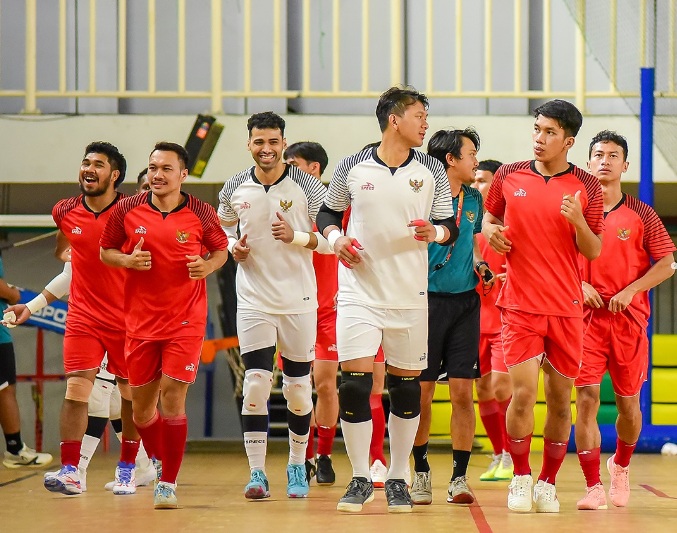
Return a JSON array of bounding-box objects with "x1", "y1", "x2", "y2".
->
[{"x1": 125, "y1": 336, "x2": 204, "y2": 387}]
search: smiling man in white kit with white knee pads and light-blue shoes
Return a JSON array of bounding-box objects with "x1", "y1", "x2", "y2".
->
[{"x1": 218, "y1": 112, "x2": 329, "y2": 499}]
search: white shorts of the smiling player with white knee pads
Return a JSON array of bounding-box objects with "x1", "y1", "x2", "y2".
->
[{"x1": 237, "y1": 309, "x2": 317, "y2": 363}]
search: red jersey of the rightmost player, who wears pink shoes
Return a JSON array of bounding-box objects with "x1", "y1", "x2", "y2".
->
[{"x1": 579, "y1": 194, "x2": 675, "y2": 327}]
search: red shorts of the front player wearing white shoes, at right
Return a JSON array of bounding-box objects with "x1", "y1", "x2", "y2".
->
[{"x1": 501, "y1": 309, "x2": 583, "y2": 379}]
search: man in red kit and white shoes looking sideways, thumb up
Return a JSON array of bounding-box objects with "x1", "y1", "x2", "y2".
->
[{"x1": 482, "y1": 100, "x2": 604, "y2": 513}]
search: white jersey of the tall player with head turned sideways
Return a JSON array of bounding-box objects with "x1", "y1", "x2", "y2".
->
[{"x1": 325, "y1": 148, "x2": 453, "y2": 309}]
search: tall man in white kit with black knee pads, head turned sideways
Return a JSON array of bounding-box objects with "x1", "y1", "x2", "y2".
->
[{"x1": 317, "y1": 87, "x2": 458, "y2": 513}]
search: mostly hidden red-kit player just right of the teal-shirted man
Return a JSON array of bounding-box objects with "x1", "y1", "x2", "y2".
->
[{"x1": 473, "y1": 159, "x2": 512, "y2": 481}]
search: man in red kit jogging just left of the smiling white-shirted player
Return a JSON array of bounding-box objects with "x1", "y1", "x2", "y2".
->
[{"x1": 100, "y1": 142, "x2": 228, "y2": 509}]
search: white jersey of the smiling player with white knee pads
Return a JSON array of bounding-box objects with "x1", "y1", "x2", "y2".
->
[{"x1": 218, "y1": 166, "x2": 327, "y2": 314}]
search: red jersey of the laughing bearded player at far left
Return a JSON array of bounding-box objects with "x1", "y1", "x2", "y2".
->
[{"x1": 52, "y1": 193, "x2": 125, "y2": 331}]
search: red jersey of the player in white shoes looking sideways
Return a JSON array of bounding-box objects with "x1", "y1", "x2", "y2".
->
[{"x1": 485, "y1": 161, "x2": 604, "y2": 317}]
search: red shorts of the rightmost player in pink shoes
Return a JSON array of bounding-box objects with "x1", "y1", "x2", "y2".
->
[{"x1": 575, "y1": 309, "x2": 649, "y2": 396}]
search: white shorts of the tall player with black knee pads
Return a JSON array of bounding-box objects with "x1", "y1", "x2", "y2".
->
[{"x1": 336, "y1": 302, "x2": 428, "y2": 370}]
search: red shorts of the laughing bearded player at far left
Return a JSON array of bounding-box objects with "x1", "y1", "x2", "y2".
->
[{"x1": 63, "y1": 325, "x2": 127, "y2": 379}]
